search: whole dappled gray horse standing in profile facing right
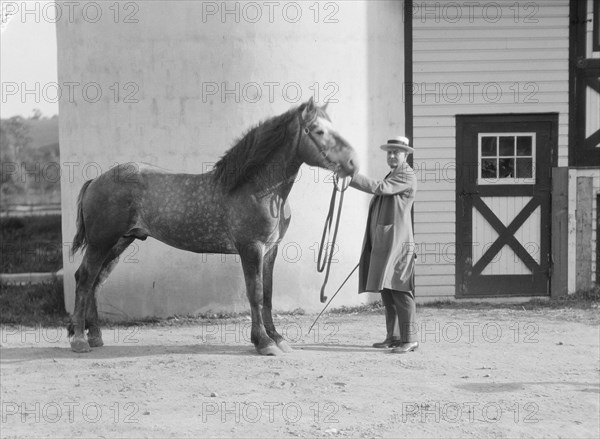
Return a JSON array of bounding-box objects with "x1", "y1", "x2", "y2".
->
[{"x1": 69, "y1": 98, "x2": 358, "y2": 355}]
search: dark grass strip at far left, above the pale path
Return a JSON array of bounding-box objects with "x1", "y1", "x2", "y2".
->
[{"x1": 0, "y1": 215, "x2": 63, "y2": 273}]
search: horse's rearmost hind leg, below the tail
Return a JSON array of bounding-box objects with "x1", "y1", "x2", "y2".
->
[{"x1": 69, "y1": 245, "x2": 108, "y2": 352}]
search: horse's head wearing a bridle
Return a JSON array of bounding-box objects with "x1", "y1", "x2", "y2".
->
[{"x1": 299, "y1": 97, "x2": 358, "y2": 177}]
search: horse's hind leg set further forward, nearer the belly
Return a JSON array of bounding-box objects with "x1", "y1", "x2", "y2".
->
[{"x1": 85, "y1": 238, "x2": 135, "y2": 348}]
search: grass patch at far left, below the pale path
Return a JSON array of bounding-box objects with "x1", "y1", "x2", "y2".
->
[{"x1": 0, "y1": 279, "x2": 68, "y2": 326}]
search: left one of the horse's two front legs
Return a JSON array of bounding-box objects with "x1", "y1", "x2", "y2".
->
[{"x1": 240, "y1": 243, "x2": 281, "y2": 355}]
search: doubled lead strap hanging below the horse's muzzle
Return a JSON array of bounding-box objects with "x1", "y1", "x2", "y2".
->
[{"x1": 317, "y1": 176, "x2": 350, "y2": 303}]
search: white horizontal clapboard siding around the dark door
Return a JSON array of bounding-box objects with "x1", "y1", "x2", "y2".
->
[{"x1": 412, "y1": 0, "x2": 569, "y2": 297}]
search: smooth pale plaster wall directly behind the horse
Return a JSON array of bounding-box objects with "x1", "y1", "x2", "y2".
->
[{"x1": 57, "y1": 1, "x2": 404, "y2": 318}]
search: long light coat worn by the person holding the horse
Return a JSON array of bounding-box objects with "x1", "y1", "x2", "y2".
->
[{"x1": 350, "y1": 163, "x2": 417, "y2": 293}]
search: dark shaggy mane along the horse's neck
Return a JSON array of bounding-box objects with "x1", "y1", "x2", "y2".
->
[{"x1": 214, "y1": 104, "x2": 306, "y2": 192}]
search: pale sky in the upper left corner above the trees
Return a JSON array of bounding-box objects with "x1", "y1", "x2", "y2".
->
[{"x1": 0, "y1": 1, "x2": 58, "y2": 119}]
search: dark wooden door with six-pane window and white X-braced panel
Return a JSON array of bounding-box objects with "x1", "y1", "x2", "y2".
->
[{"x1": 456, "y1": 114, "x2": 558, "y2": 297}]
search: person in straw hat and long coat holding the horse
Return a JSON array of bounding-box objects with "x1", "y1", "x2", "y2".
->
[{"x1": 350, "y1": 136, "x2": 419, "y2": 353}]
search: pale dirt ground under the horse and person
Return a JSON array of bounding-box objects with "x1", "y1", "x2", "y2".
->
[{"x1": 0, "y1": 308, "x2": 600, "y2": 438}]
